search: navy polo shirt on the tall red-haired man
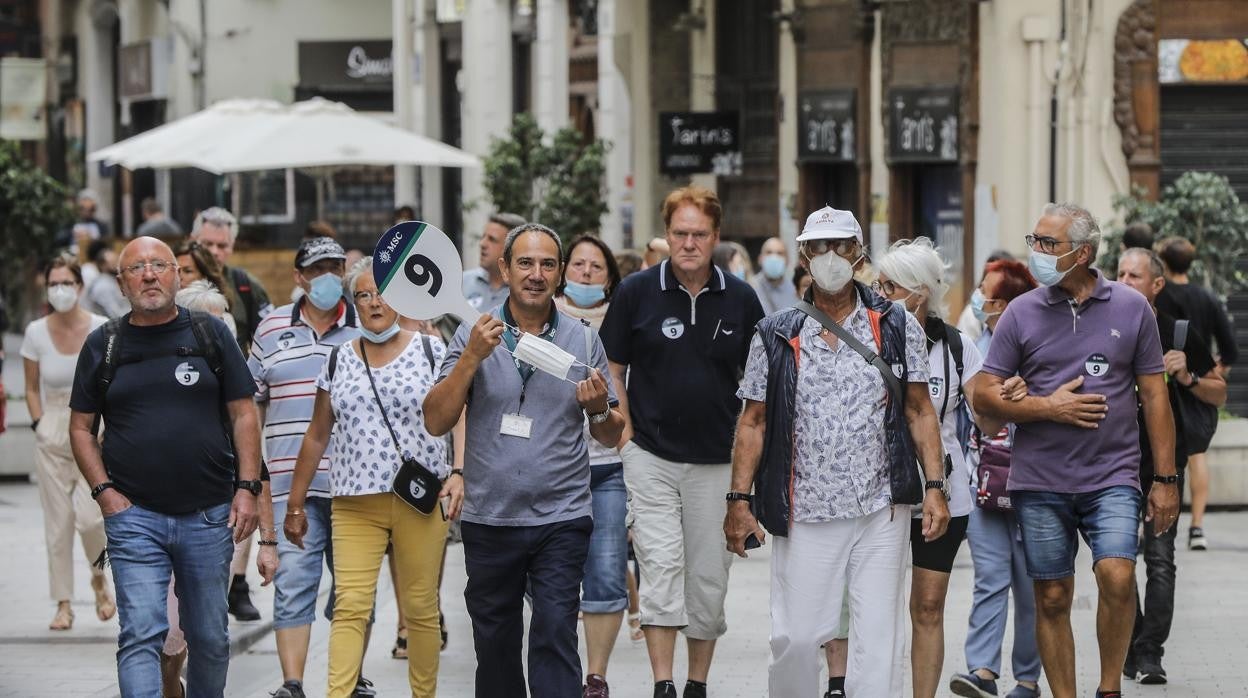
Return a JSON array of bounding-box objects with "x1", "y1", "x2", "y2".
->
[{"x1": 599, "y1": 261, "x2": 764, "y2": 465}]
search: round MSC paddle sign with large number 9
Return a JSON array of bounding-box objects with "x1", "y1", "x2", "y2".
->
[{"x1": 373, "y1": 221, "x2": 480, "y2": 325}]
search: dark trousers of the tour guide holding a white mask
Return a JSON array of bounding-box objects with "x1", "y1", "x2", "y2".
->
[{"x1": 462, "y1": 516, "x2": 594, "y2": 698}]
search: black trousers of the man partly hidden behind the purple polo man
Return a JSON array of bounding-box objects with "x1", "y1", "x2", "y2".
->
[{"x1": 1131, "y1": 471, "x2": 1183, "y2": 659}]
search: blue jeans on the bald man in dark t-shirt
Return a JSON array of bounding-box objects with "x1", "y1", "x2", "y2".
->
[{"x1": 104, "y1": 503, "x2": 233, "y2": 698}]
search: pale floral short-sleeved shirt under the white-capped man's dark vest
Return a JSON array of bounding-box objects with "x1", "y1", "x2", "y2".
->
[{"x1": 736, "y1": 301, "x2": 929, "y2": 523}]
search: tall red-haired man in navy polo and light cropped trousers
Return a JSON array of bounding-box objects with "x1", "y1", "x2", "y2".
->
[{"x1": 602, "y1": 186, "x2": 764, "y2": 698}]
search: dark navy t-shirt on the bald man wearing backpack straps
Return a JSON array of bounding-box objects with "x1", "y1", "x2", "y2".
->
[{"x1": 70, "y1": 307, "x2": 256, "y2": 514}]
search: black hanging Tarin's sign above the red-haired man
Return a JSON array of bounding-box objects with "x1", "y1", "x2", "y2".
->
[{"x1": 659, "y1": 111, "x2": 741, "y2": 176}]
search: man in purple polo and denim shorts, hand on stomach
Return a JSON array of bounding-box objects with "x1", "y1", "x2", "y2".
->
[{"x1": 975, "y1": 204, "x2": 1178, "y2": 698}]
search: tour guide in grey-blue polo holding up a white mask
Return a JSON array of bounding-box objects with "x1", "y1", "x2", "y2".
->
[{"x1": 424, "y1": 224, "x2": 624, "y2": 698}]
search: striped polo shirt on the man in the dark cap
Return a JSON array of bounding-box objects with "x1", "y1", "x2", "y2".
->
[{"x1": 247, "y1": 297, "x2": 359, "y2": 502}]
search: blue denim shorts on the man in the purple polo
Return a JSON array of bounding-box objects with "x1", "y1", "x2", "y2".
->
[{"x1": 1011, "y1": 484, "x2": 1141, "y2": 579}]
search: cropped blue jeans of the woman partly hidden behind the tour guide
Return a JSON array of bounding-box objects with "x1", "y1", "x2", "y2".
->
[{"x1": 580, "y1": 463, "x2": 628, "y2": 613}]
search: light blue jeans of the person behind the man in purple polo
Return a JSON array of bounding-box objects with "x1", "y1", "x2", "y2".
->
[{"x1": 966, "y1": 496, "x2": 1040, "y2": 681}]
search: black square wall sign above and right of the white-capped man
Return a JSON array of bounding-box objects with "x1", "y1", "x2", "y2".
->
[{"x1": 889, "y1": 87, "x2": 958, "y2": 162}]
